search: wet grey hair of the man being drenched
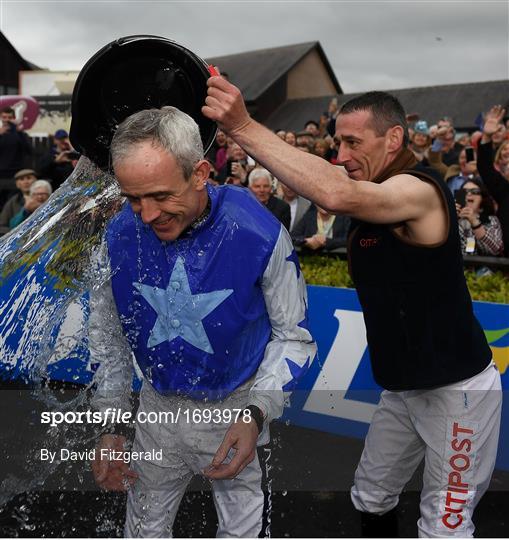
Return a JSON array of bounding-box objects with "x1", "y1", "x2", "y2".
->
[{"x1": 110, "y1": 107, "x2": 203, "y2": 180}]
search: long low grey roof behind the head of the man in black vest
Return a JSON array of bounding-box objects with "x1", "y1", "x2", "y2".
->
[{"x1": 265, "y1": 80, "x2": 509, "y2": 131}]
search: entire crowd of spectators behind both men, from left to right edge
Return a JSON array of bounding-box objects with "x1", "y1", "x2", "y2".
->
[{"x1": 0, "y1": 99, "x2": 509, "y2": 266}]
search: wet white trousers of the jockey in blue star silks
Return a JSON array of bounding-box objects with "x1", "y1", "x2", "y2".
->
[{"x1": 124, "y1": 384, "x2": 264, "y2": 538}]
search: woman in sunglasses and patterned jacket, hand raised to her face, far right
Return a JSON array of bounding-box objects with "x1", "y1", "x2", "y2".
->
[{"x1": 456, "y1": 178, "x2": 504, "y2": 257}]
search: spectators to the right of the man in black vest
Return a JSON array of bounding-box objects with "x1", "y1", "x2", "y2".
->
[{"x1": 402, "y1": 105, "x2": 509, "y2": 257}]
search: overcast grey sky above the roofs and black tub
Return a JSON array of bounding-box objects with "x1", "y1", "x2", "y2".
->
[{"x1": 0, "y1": 0, "x2": 509, "y2": 92}]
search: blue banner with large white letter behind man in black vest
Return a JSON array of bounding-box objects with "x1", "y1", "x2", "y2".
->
[{"x1": 284, "y1": 286, "x2": 509, "y2": 470}]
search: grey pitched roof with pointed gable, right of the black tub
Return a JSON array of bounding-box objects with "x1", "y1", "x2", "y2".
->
[{"x1": 206, "y1": 41, "x2": 342, "y2": 102}]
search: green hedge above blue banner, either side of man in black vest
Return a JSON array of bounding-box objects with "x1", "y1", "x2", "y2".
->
[{"x1": 299, "y1": 255, "x2": 509, "y2": 304}]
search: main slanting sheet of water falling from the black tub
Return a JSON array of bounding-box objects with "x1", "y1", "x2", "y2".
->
[{"x1": 0, "y1": 157, "x2": 120, "y2": 382}]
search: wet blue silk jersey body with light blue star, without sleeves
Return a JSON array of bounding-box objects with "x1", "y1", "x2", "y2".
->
[{"x1": 106, "y1": 186, "x2": 281, "y2": 400}]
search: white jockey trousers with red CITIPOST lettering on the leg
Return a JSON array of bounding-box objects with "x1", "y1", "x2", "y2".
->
[{"x1": 351, "y1": 362, "x2": 502, "y2": 538}]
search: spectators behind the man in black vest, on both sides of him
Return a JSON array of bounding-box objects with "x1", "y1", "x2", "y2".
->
[{"x1": 207, "y1": 99, "x2": 509, "y2": 264}]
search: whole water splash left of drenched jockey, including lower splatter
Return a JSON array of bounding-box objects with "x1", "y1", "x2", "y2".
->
[{"x1": 0, "y1": 157, "x2": 122, "y2": 506}]
